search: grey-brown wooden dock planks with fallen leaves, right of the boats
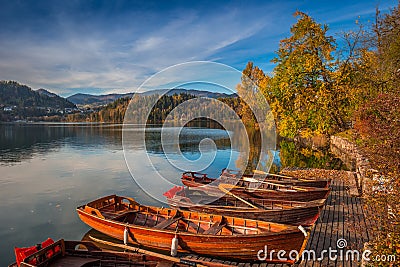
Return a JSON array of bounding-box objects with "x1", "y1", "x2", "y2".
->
[{"x1": 290, "y1": 180, "x2": 371, "y2": 267}]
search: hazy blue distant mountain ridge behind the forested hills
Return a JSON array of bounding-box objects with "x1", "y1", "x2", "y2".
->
[{"x1": 67, "y1": 89, "x2": 237, "y2": 105}]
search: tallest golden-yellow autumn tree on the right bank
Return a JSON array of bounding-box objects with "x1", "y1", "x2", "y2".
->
[{"x1": 267, "y1": 12, "x2": 352, "y2": 137}]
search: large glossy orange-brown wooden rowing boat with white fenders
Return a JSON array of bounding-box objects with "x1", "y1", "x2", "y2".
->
[{"x1": 77, "y1": 195, "x2": 309, "y2": 263}]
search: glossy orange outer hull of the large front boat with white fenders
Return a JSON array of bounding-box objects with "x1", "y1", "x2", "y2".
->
[{"x1": 77, "y1": 196, "x2": 309, "y2": 264}]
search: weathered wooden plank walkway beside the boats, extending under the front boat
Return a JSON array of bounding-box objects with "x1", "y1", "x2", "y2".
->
[{"x1": 183, "y1": 179, "x2": 371, "y2": 267}]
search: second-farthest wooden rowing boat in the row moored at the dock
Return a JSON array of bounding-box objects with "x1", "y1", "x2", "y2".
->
[{"x1": 181, "y1": 172, "x2": 330, "y2": 202}]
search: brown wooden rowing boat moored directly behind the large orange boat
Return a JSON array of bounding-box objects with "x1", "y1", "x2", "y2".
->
[{"x1": 164, "y1": 186, "x2": 325, "y2": 226}]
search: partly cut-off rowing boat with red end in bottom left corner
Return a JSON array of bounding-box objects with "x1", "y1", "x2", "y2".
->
[{"x1": 9, "y1": 239, "x2": 180, "y2": 267}]
